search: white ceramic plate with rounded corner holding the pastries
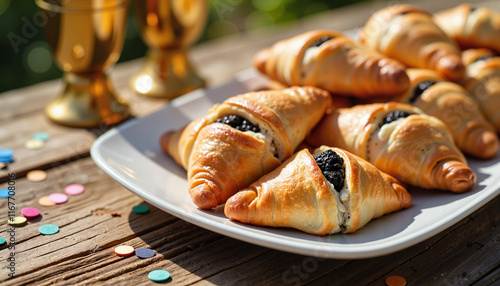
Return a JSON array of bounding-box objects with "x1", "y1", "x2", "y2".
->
[{"x1": 91, "y1": 67, "x2": 500, "y2": 259}]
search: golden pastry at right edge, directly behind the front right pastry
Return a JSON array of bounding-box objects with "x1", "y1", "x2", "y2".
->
[{"x1": 394, "y1": 69, "x2": 498, "y2": 159}]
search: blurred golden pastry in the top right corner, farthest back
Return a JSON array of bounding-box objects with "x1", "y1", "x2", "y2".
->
[{"x1": 434, "y1": 4, "x2": 500, "y2": 53}]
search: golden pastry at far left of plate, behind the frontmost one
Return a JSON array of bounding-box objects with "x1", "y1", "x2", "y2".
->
[{"x1": 160, "y1": 87, "x2": 331, "y2": 209}]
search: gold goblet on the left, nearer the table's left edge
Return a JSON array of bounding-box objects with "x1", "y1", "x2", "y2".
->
[{"x1": 36, "y1": 0, "x2": 130, "y2": 127}]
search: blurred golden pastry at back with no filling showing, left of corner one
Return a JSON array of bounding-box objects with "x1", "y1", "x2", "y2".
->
[{"x1": 359, "y1": 4, "x2": 465, "y2": 81}]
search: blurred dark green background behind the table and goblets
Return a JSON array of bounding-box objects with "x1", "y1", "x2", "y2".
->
[{"x1": 0, "y1": 0, "x2": 369, "y2": 92}]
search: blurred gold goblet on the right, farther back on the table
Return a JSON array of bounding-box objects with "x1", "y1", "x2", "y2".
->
[{"x1": 131, "y1": 0, "x2": 208, "y2": 99}]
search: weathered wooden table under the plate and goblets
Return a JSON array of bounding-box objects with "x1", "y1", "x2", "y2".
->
[{"x1": 0, "y1": 0, "x2": 500, "y2": 285}]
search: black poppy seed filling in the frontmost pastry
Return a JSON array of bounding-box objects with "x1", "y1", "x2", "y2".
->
[{"x1": 314, "y1": 149, "x2": 345, "y2": 192}]
